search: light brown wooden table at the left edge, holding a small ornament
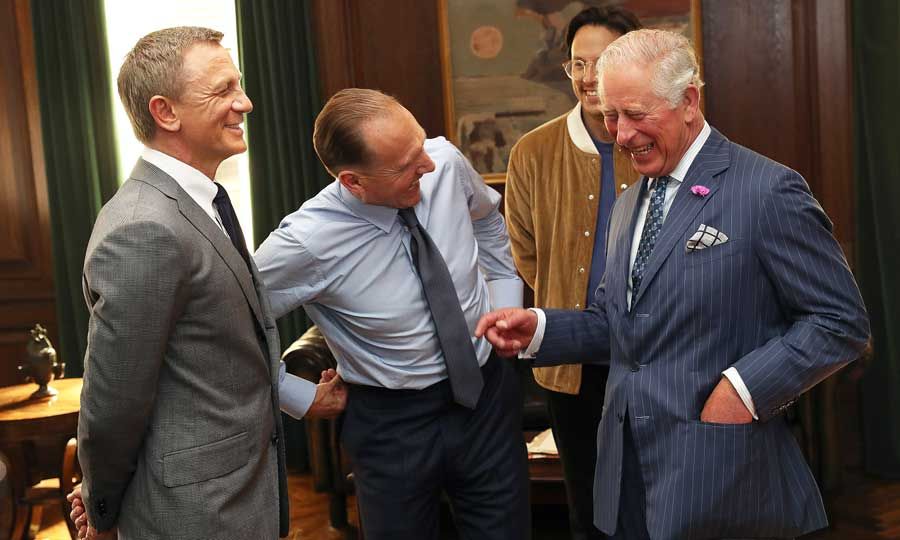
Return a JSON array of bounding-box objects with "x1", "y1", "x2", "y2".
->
[{"x1": 0, "y1": 378, "x2": 81, "y2": 540}]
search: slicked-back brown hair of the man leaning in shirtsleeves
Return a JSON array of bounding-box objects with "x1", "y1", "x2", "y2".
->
[{"x1": 313, "y1": 88, "x2": 403, "y2": 176}]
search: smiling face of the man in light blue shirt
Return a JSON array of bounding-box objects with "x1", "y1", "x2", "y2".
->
[{"x1": 342, "y1": 106, "x2": 434, "y2": 208}]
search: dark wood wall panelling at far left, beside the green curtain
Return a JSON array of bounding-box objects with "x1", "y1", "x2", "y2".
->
[{"x1": 0, "y1": 0, "x2": 57, "y2": 386}]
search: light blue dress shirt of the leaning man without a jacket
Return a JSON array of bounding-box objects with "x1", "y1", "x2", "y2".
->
[{"x1": 254, "y1": 137, "x2": 522, "y2": 389}]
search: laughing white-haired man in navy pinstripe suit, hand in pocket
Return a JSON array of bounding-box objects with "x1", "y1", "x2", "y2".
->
[{"x1": 476, "y1": 30, "x2": 869, "y2": 540}]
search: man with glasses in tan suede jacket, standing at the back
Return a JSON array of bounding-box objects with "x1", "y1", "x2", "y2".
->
[{"x1": 506, "y1": 6, "x2": 640, "y2": 539}]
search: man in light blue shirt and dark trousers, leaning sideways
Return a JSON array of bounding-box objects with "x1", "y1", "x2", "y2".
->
[{"x1": 254, "y1": 89, "x2": 530, "y2": 540}]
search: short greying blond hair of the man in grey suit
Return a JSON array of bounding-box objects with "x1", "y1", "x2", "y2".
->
[{"x1": 117, "y1": 26, "x2": 222, "y2": 143}]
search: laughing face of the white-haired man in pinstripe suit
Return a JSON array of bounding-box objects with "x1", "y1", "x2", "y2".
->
[{"x1": 600, "y1": 64, "x2": 703, "y2": 178}]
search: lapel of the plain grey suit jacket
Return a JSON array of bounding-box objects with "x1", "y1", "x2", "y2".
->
[{"x1": 131, "y1": 159, "x2": 265, "y2": 335}]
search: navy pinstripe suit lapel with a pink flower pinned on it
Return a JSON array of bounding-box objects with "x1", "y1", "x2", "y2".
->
[{"x1": 629, "y1": 129, "x2": 730, "y2": 310}]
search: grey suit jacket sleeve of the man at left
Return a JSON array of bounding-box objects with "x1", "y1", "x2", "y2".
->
[{"x1": 78, "y1": 222, "x2": 187, "y2": 531}]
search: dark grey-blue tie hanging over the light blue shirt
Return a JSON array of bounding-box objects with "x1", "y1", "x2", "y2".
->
[{"x1": 399, "y1": 208, "x2": 484, "y2": 409}]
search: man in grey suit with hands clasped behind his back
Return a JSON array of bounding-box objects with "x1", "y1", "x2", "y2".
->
[{"x1": 73, "y1": 27, "x2": 346, "y2": 540}]
